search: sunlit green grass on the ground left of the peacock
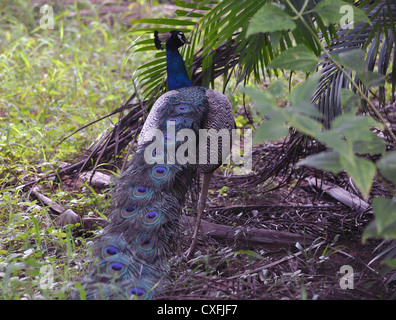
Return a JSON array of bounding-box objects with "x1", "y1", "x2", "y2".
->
[{"x1": 0, "y1": 0, "x2": 140, "y2": 299}]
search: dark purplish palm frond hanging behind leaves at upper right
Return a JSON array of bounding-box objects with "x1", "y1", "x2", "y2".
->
[{"x1": 313, "y1": 1, "x2": 396, "y2": 127}]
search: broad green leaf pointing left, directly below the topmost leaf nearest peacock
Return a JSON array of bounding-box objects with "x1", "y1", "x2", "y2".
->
[{"x1": 269, "y1": 45, "x2": 319, "y2": 72}]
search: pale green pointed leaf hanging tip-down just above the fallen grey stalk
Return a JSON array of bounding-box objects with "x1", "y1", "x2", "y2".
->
[{"x1": 340, "y1": 154, "x2": 377, "y2": 200}]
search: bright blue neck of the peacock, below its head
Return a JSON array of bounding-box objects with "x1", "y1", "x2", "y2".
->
[{"x1": 166, "y1": 48, "x2": 192, "y2": 91}]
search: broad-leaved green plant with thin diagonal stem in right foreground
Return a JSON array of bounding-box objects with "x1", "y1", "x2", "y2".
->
[{"x1": 244, "y1": 1, "x2": 396, "y2": 258}]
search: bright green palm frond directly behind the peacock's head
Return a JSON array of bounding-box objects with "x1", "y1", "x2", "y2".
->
[{"x1": 131, "y1": 0, "x2": 266, "y2": 100}]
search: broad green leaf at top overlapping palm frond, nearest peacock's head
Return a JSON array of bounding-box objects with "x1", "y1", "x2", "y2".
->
[{"x1": 246, "y1": 3, "x2": 296, "y2": 36}]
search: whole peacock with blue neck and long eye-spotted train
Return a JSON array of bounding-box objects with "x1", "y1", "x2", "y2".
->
[{"x1": 82, "y1": 30, "x2": 235, "y2": 299}]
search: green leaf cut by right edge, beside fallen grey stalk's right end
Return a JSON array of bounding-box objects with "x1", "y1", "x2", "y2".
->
[{"x1": 373, "y1": 198, "x2": 396, "y2": 234}]
